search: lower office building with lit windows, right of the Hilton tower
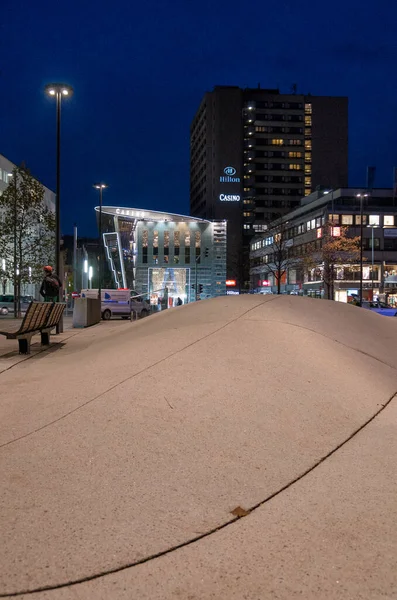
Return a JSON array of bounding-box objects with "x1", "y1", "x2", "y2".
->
[{"x1": 250, "y1": 188, "x2": 397, "y2": 306}]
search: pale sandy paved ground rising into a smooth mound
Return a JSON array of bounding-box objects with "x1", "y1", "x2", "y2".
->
[{"x1": 0, "y1": 295, "x2": 397, "y2": 600}]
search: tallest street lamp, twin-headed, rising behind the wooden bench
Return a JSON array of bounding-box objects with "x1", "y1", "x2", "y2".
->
[{"x1": 45, "y1": 83, "x2": 73, "y2": 333}]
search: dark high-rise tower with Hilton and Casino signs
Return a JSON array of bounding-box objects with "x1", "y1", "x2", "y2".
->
[{"x1": 190, "y1": 86, "x2": 348, "y2": 289}]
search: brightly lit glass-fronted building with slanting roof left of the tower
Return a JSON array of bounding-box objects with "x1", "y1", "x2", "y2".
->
[{"x1": 95, "y1": 206, "x2": 226, "y2": 303}]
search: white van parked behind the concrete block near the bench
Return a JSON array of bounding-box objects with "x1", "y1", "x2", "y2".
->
[{"x1": 81, "y1": 289, "x2": 150, "y2": 321}]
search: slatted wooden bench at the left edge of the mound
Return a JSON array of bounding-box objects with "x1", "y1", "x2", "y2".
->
[{"x1": 0, "y1": 302, "x2": 65, "y2": 354}]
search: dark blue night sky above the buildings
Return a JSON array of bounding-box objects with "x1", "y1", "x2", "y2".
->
[{"x1": 0, "y1": 0, "x2": 397, "y2": 235}]
